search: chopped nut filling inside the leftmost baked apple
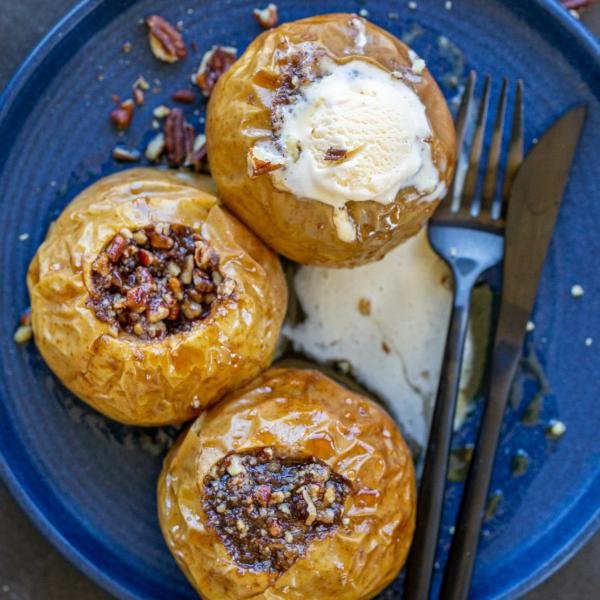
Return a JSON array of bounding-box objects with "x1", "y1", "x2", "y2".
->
[{"x1": 87, "y1": 223, "x2": 235, "y2": 340}]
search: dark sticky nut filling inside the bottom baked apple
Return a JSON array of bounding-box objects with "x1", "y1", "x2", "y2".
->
[{"x1": 204, "y1": 448, "x2": 351, "y2": 573}]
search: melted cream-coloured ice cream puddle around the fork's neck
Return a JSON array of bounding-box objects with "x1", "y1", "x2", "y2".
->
[{"x1": 284, "y1": 231, "x2": 490, "y2": 446}]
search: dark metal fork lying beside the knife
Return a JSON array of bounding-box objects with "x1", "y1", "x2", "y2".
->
[{"x1": 404, "y1": 71, "x2": 523, "y2": 600}]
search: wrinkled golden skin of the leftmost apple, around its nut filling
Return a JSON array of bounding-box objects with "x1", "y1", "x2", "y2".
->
[{"x1": 27, "y1": 169, "x2": 287, "y2": 425}]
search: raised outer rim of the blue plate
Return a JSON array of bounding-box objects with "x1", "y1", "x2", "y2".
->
[{"x1": 0, "y1": 0, "x2": 600, "y2": 600}]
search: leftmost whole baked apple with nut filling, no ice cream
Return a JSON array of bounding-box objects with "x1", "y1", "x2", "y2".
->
[{"x1": 27, "y1": 169, "x2": 287, "y2": 425}]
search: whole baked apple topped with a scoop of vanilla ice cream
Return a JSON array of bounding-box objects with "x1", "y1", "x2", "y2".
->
[{"x1": 206, "y1": 14, "x2": 456, "y2": 267}]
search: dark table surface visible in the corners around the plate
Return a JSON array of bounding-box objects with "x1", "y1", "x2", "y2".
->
[{"x1": 0, "y1": 0, "x2": 600, "y2": 600}]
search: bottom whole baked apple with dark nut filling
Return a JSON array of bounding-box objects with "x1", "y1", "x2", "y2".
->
[{"x1": 158, "y1": 369, "x2": 415, "y2": 600}]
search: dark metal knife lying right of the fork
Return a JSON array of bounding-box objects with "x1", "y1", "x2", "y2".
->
[{"x1": 440, "y1": 106, "x2": 586, "y2": 600}]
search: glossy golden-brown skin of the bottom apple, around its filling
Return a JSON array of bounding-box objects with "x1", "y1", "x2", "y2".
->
[{"x1": 158, "y1": 369, "x2": 415, "y2": 600}]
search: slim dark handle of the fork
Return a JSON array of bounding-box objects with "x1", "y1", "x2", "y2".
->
[{"x1": 404, "y1": 276, "x2": 475, "y2": 600}]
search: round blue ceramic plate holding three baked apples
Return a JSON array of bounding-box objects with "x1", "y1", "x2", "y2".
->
[{"x1": 0, "y1": 0, "x2": 600, "y2": 600}]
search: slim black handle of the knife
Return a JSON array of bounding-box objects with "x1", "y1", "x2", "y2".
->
[{"x1": 440, "y1": 340, "x2": 521, "y2": 600}]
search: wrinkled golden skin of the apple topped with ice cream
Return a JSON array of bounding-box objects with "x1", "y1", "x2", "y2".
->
[{"x1": 206, "y1": 14, "x2": 456, "y2": 267}]
